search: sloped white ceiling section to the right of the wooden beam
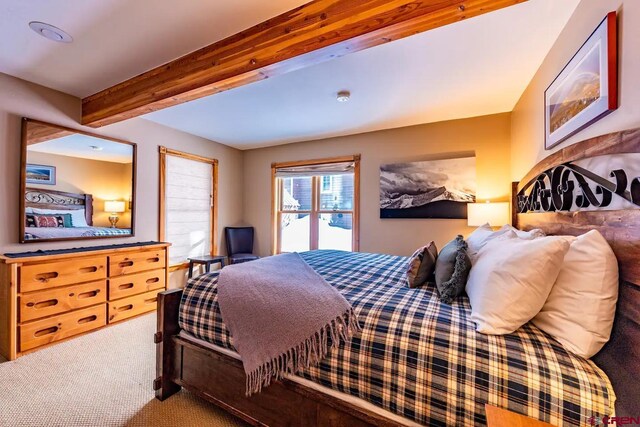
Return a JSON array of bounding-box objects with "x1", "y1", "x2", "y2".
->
[{"x1": 145, "y1": 0, "x2": 579, "y2": 149}]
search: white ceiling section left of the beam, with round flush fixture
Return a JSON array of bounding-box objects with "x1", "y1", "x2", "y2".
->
[{"x1": 0, "y1": 0, "x2": 306, "y2": 98}]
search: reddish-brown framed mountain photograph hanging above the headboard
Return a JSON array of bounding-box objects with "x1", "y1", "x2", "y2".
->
[{"x1": 544, "y1": 12, "x2": 618, "y2": 150}]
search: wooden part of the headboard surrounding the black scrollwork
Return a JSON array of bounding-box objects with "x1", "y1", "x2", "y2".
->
[{"x1": 512, "y1": 129, "x2": 640, "y2": 417}]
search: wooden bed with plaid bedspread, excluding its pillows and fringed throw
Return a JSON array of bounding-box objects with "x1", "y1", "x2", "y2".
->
[{"x1": 154, "y1": 131, "x2": 640, "y2": 425}]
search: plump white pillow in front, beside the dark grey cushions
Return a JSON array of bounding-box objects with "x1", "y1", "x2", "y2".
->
[{"x1": 466, "y1": 231, "x2": 575, "y2": 335}]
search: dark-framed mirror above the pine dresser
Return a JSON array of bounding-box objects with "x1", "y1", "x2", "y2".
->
[{"x1": 19, "y1": 118, "x2": 136, "y2": 243}]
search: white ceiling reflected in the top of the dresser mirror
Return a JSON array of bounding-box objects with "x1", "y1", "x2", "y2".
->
[{"x1": 27, "y1": 133, "x2": 133, "y2": 164}]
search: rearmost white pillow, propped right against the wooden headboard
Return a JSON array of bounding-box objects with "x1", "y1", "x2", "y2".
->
[{"x1": 532, "y1": 230, "x2": 618, "y2": 359}]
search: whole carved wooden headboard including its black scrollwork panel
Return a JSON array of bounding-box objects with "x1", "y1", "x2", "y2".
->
[{"x1": 512, "y1": 129, "x2": 640, "y2": 417}]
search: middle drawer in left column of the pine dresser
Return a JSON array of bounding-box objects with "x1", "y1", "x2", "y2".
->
[{"x1": 19, "y1": 280, "x2": 107, "y2": 322}]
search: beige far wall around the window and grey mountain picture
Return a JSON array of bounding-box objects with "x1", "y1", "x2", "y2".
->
[{"x1": 244, "y1": 113, "x2": 510, "y2": 255}]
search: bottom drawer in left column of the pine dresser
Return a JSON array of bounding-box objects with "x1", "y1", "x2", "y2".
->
[{"x1": 20, "y1": 304, "x2": 107, "y2": 351}]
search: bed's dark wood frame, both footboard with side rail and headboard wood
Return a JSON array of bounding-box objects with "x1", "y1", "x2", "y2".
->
[{"x1": 154, "y1": 129, "x2": 640, "y2": 426}]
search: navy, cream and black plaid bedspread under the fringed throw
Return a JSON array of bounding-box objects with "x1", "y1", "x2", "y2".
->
[{"x1": 180, "y1": 251, "x2": 615, "y2": 426}]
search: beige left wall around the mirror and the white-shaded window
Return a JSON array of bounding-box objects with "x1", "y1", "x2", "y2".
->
[{"x1": 0, "y1": 73, "x2": 243, "y2": 288}]
